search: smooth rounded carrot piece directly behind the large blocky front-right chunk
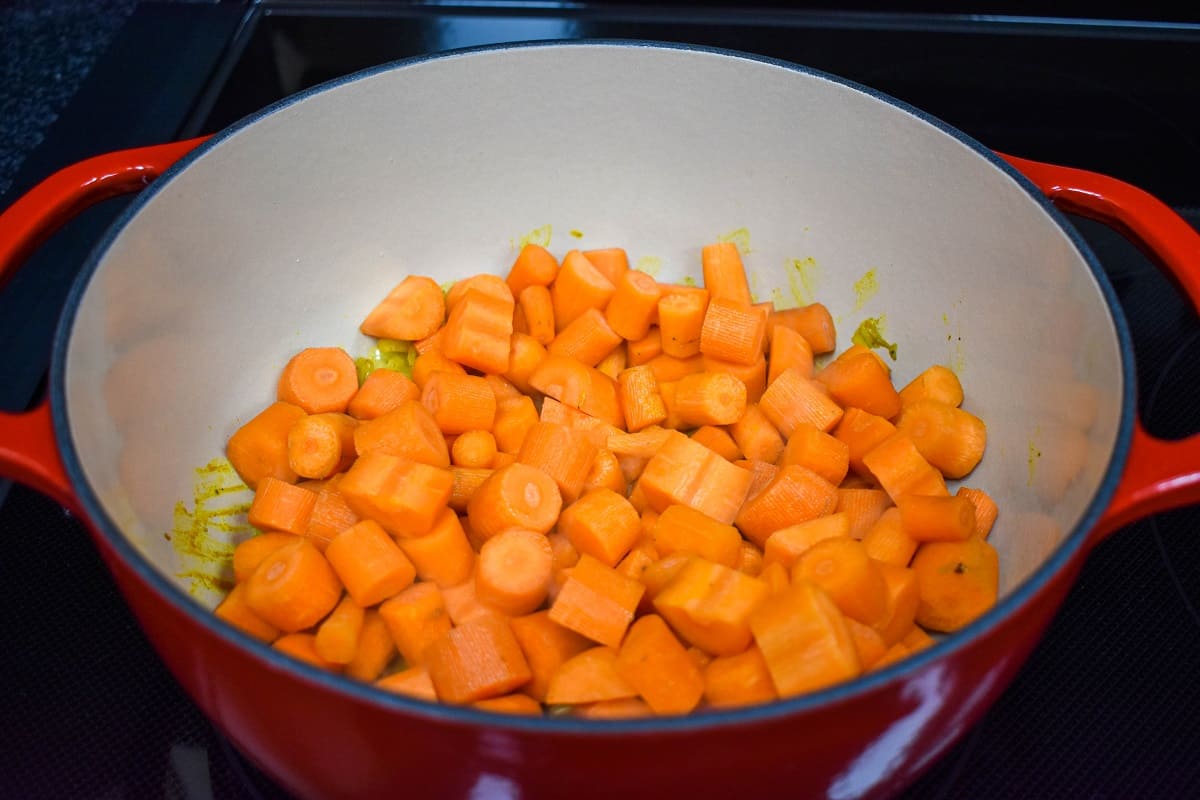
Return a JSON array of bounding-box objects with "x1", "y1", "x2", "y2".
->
[{"x1": 792, "y1": 536, "x2": 887, "y2": 625}]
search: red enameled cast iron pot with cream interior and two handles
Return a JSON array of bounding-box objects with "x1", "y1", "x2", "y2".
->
[{"x1": 0, "y1": 42, "x2": 1200, "y2": 798}]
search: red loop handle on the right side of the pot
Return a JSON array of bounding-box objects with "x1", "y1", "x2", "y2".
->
[{"x1": 998, "y1": 154, "x2": 1200, "y2": 546}]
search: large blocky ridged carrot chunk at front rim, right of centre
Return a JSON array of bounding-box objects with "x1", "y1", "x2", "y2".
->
[{"x1": 750, "y1": 581, "x2": 863, "y2": 697}]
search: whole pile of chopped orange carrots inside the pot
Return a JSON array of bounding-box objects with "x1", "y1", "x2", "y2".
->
[{"x1": 216, "y1": 242, "x2": 998, "y2": 718}]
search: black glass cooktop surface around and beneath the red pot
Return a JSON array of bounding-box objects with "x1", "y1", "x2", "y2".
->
[{"x1": 0, "y1": 2, "x2": 1200, "y2": 800}]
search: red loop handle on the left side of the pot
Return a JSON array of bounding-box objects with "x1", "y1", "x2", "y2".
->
[{"x1": 0, "y1": 137, "x2": 208, "y2": 511}]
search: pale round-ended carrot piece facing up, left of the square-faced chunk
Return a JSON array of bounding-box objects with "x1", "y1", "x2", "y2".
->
[{"x1": 475, "y1": 530, "x2": 554, "y2": 616}]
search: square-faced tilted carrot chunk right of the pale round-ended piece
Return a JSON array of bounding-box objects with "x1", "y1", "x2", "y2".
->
[{"x1": 550, "y1": 553, "x2": 644, "y2": 648}]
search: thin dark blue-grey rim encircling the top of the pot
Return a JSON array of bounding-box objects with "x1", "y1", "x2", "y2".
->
[{"x1": 49, "y1": 38, "x2": 1136, "y2": 735}]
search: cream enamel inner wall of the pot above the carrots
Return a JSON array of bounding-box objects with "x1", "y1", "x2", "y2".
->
[{"x1": 58, "y1": 44, "x2": 1122, "y2": 603}]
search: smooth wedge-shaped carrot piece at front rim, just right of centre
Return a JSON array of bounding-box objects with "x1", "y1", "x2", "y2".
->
[{"x1": 616, "y1": 614, "x2": 704, "y2": 714}]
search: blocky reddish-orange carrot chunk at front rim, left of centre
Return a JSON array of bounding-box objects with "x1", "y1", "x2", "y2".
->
[{"x1": 424, "y1": 616, "x2": 532, "y2": 703}]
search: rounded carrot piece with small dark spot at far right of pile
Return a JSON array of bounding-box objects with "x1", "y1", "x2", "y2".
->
[{"x1": 912, "y1": 536, "x2": 1000, "y2": 633}]
